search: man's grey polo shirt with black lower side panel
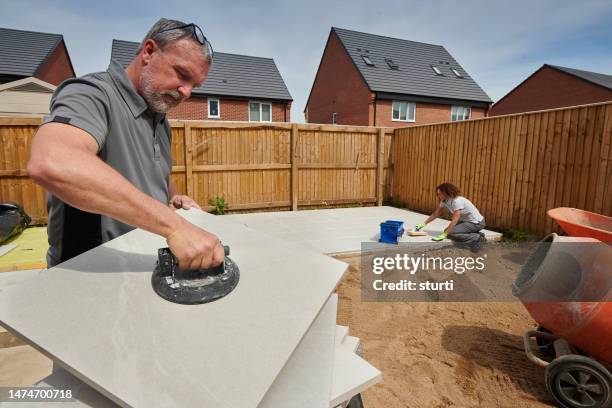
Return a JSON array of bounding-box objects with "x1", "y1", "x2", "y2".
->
[{"x1": 43, "y1": 61, "x2": 172, "y2": 267}]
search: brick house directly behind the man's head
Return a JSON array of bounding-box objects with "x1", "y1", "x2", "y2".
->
[{"x1": 111, "y1": 40, "x2": 292, "y2": 122}]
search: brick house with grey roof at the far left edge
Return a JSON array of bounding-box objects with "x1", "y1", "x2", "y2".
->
[{"x1": 0, "y1": 28, "x2": 75, "y2": 85}]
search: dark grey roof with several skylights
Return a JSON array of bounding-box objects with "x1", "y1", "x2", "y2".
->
[{"x1": 332, "y1": 27, "x2": 492, "y2": 103}]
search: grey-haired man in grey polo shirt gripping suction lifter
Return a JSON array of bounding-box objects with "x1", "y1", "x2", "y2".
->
[{"x1": 28, "y1": 19, "x2": 224, "y2": 269}]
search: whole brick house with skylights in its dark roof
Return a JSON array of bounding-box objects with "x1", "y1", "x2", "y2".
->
[{"x1": 304, "y1": 27, "x2": 492, "y2": 127}]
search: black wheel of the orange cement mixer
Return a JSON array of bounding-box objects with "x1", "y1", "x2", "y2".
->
[{"x1": 546, "y1": 354, "x2": 612, "y2": 408}]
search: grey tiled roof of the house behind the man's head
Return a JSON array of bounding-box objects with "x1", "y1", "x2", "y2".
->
[{"x1": 111, "y1": 40, "x2": 292, "y2": 101}]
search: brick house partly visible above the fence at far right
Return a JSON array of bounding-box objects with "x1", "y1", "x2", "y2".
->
[{"x1": 489, "y1": 64, "x2": 612, "y2": 116}]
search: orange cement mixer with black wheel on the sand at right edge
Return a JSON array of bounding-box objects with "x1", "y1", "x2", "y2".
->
[{"x1": 513, "y1": 225, "x2": 612, "y2": 408}]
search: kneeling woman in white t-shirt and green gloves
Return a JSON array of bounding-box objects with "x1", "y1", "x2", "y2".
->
[{"x1": 415, "y1": 183, "x2": 485, "y2": 247}]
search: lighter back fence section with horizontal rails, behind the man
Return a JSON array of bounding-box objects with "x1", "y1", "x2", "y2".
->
[{"x1": 0, "y1": 118, "x2": 393, "y2": 222}]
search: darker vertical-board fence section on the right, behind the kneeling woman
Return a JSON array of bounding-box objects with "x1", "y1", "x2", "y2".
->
[{"x1": 391, "y1": 102, "x2": 612, "y2": 234}]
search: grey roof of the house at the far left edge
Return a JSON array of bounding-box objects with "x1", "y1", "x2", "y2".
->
[{"x1": 0, "y1": 28, "x2": 63, "y2": 77}]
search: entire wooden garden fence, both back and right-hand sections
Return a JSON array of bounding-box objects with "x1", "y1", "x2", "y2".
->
[{"x1": 0, "y1": 103, "x2": 612, "y2": 234}]
